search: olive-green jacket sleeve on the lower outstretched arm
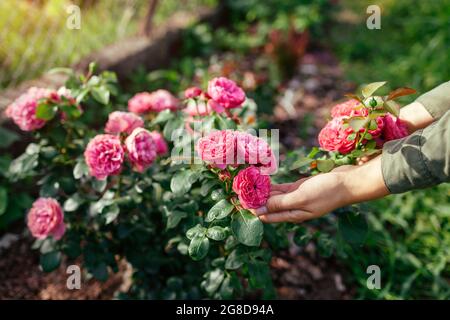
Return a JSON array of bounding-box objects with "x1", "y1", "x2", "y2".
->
[{"x1": 381, "y1": 111, "x2": 450, "y2": 193}]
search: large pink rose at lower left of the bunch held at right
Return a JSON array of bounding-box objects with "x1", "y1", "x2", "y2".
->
[{"x1": 319, "y1": 117, "x2": 356, "y2": 154}]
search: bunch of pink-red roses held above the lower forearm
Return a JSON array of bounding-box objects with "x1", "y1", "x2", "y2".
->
[{"x1": 318, "y1": 99, "x2": 408, "y2": 154}]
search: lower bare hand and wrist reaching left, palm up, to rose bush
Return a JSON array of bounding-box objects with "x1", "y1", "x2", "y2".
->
[{"x1": 252, "y1": 157, "x2": 389, "y2": 223}]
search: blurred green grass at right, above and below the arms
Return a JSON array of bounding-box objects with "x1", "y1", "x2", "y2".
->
[{"x1": 327, "y1": 0, "x2": 450, "y2": 299}]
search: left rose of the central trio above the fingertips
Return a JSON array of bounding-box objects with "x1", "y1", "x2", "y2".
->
[{"x1": 196, "y1": 130, "x2": 236, "y2": 169}]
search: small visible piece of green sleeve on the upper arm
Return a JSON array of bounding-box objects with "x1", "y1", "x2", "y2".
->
[{"x1": 416, "y1": 81, "x2": 450, "y2": 119}]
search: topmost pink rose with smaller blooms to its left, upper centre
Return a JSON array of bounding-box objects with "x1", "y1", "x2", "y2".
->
[{"x1": 184, "y1": 77, "x2": 246, "y2": 116}]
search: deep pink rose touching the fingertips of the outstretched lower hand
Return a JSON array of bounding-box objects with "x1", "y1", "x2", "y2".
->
[{"x1": 233, "y1": 166, "x2": 270, "y2": 209}]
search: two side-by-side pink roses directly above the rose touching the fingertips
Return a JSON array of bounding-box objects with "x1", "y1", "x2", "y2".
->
[{"x1": 196, "y1": 130, "x2": 277, "y2": 174}]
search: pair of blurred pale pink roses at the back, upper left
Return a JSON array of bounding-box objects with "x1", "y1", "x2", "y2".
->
[{"x1": 128, "y1": 89, "x2": 180, "y2": 113}]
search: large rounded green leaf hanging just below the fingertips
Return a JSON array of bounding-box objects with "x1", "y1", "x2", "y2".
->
[{"x1": 231, "y1": 210, "x2": 264, "y2": 247}]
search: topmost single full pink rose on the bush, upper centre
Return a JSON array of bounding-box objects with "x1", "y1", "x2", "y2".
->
[{"x1": 208, "y1": 77, "x2": 245, "y2": 109}]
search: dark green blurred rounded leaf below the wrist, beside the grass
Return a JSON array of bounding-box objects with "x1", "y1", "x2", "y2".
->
[{"x1": 338, "y1": 212, "x2": 369, "y2": 244}]
